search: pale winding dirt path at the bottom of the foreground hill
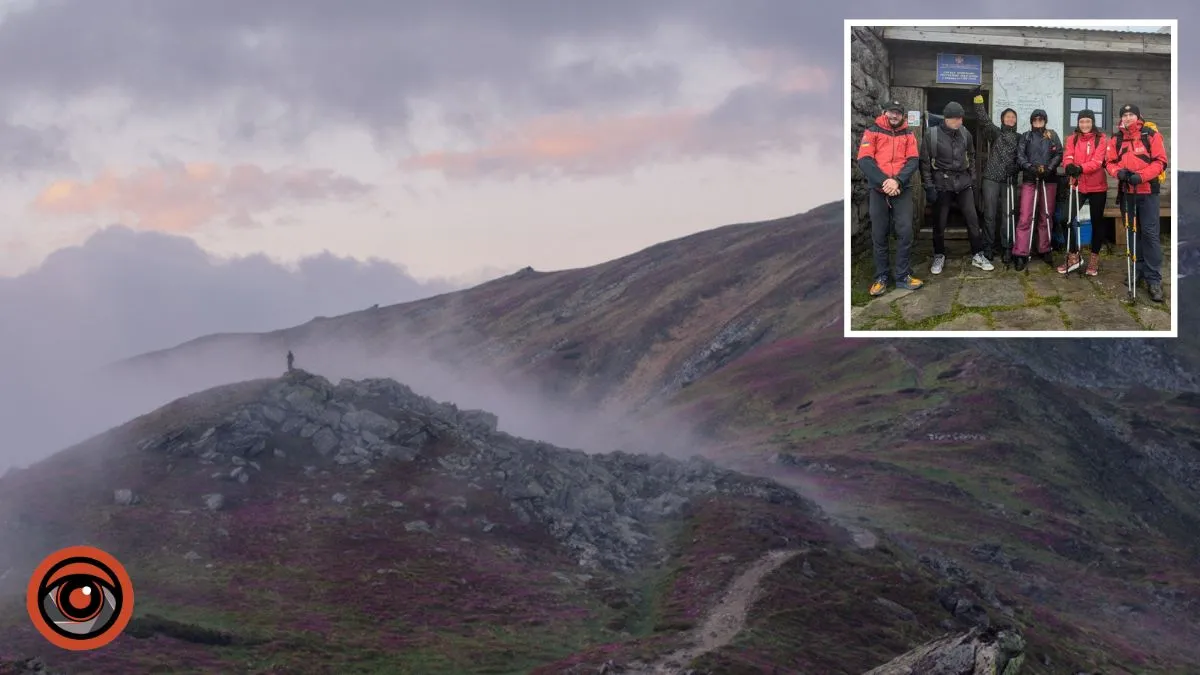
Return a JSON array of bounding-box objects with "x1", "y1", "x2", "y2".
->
[{"x1": 623, "y1": 549, "x2": 800, "y2": 675}]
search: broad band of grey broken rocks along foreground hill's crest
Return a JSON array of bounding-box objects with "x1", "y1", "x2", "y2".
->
[{"x1": 139, "y1": 370, "x2": 817, "y2": 571}]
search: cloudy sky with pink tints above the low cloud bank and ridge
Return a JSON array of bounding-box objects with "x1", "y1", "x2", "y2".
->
[{"x1": 0, "y1": 0, "x2": 1188, "y2": 280}]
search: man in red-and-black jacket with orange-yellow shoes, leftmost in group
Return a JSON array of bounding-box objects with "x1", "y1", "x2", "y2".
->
[{"x1": 858, "y1": 101, "x2": 924, "y2": 295}]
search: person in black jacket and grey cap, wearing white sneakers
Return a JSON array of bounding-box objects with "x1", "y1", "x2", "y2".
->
[{"x1": 920, "y1": 101, "x2": 995, "y2": 274}]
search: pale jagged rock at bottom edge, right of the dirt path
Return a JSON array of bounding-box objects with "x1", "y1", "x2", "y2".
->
[{"x1": 864, "y1": 628, "x2": 1025, "y2": 675}]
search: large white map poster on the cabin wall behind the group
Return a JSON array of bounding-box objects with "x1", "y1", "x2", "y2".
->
[{"x1": 991, "y1": 59, "x2": 1068, "y2": 139}]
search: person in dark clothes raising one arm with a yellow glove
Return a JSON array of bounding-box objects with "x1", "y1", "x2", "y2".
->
[{"x1": 973, "y1": 86, "x2": 1021, "y2": 264}]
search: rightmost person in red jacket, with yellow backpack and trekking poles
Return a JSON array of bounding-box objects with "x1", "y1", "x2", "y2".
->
[{"x1": 1105, "y1": 104, "x2": 1166, "y2": 303}]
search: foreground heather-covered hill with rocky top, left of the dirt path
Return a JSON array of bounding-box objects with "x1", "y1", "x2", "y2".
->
[{"x1": 0, "y1": 371, "x2": 1012, "y2": 674}]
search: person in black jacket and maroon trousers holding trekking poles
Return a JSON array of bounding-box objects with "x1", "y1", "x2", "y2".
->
[{"x1": 1013, "y1": 109, "x2": 1062, "y2": 270}]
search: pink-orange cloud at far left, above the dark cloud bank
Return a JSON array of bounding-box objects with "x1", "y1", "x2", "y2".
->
[{"x1": 30, "y1": 162, "x2": 371, "y2": 233}]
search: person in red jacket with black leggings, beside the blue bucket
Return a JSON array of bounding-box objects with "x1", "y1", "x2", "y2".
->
[{"x1": 1058, "y1": 110, "x2": 1116, "y2": 276}]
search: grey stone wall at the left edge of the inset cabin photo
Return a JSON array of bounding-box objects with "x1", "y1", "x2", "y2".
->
[{"x1": 846, "y1": 26, "x2": 892, "y2": 243}]
